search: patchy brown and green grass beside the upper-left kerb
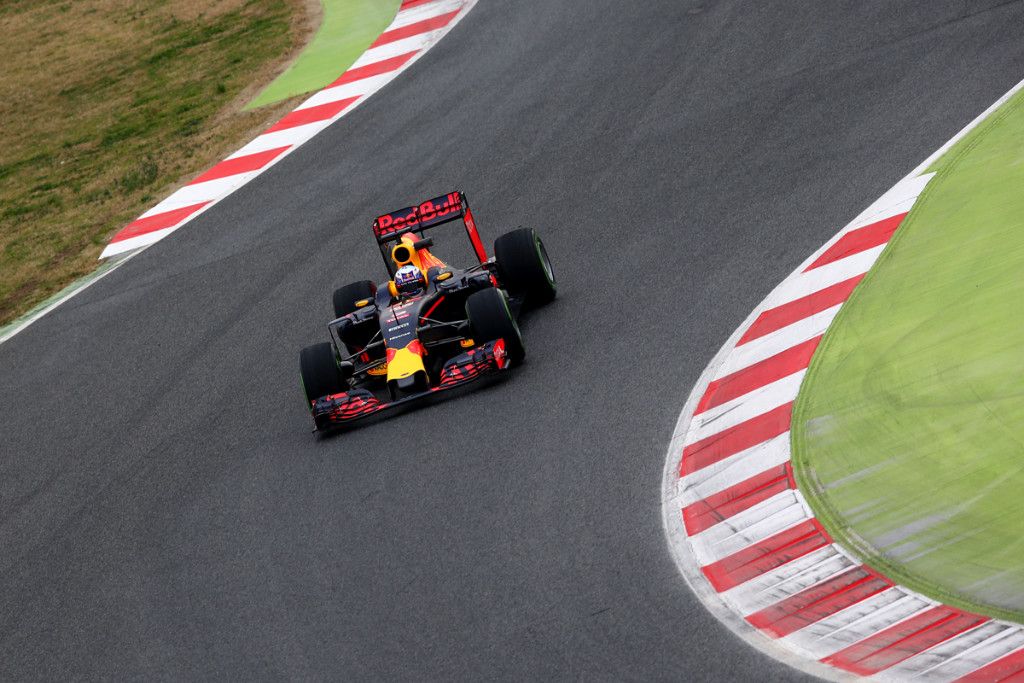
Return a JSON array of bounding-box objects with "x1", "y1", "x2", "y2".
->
[{"x1": 0, "y1": 0, "x2": 317, "y2": 324}]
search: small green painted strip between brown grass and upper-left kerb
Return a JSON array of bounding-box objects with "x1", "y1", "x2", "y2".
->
[{"x1": 248, "y1": 0, "x2": 400, "y2": 109}]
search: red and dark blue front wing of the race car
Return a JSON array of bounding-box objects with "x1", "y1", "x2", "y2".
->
[{"x1": 312, "y1": 339, "x2": 509, "y2": 429}]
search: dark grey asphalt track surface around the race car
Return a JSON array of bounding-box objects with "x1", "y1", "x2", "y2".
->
[{"x1": 0, "y1": 0, "x2": 1024, "y2": 681}]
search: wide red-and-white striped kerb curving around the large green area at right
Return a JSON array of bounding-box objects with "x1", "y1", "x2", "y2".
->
[{"x1": 662, "y1": 81, "x2": 1024, "y2": 681}]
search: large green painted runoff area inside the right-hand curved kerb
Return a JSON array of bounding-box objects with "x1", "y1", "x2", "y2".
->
[{"x1": 792, "y1": 87, "x2": 1024, "y2": 622}]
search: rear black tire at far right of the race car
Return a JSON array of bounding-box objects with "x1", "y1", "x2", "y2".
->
[{"x1": 495, "y1": 227, "x2": 558, "y2": 306}]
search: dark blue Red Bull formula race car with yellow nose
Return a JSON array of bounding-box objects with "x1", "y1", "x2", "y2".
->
[{"x1": 299, "y1": 191, "x2": 556, "y2": 430}]
